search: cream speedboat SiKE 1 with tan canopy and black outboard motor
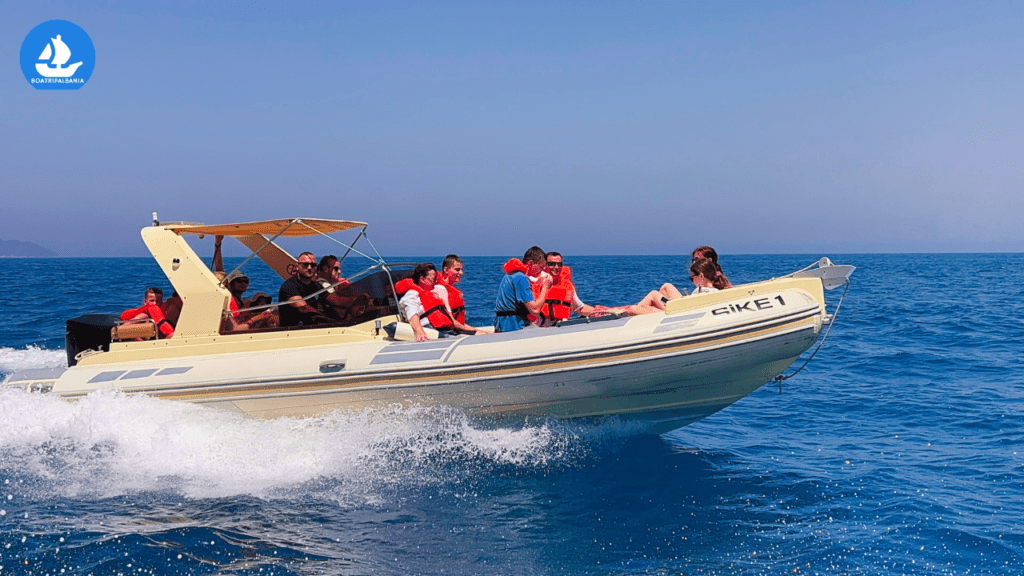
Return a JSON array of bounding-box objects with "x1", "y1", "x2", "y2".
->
[{"x1": 3, "y1": 215, "x2": 854, "y2": 429}]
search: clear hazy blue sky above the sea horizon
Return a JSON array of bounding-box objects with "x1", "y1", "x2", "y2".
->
[{"x1": 0, "y1": 0, "x2": 1024, "y2": 256}]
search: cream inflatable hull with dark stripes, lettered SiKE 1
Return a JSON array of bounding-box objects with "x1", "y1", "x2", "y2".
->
[{"x1": 0, "y1": 279, "x2": 824, "y2": 429}]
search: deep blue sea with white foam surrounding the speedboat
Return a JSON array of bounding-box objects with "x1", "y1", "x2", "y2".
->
[{"x1": 0, "y1": 254, "x2": 1024, "y2": 576}]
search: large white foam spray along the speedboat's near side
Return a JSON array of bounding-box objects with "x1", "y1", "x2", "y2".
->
[{"x1": 0, "y1": 388, "x2": 614, "y2": 502}]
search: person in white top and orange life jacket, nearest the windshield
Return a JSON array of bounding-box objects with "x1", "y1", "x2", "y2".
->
[{"x1": 394, "y1": 262, "x2": 485, "y2": 342}]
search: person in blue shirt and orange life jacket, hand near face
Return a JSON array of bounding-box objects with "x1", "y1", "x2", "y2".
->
[{"x1": 495, "y1": 246, "x2": 551, "y2": 332}]
